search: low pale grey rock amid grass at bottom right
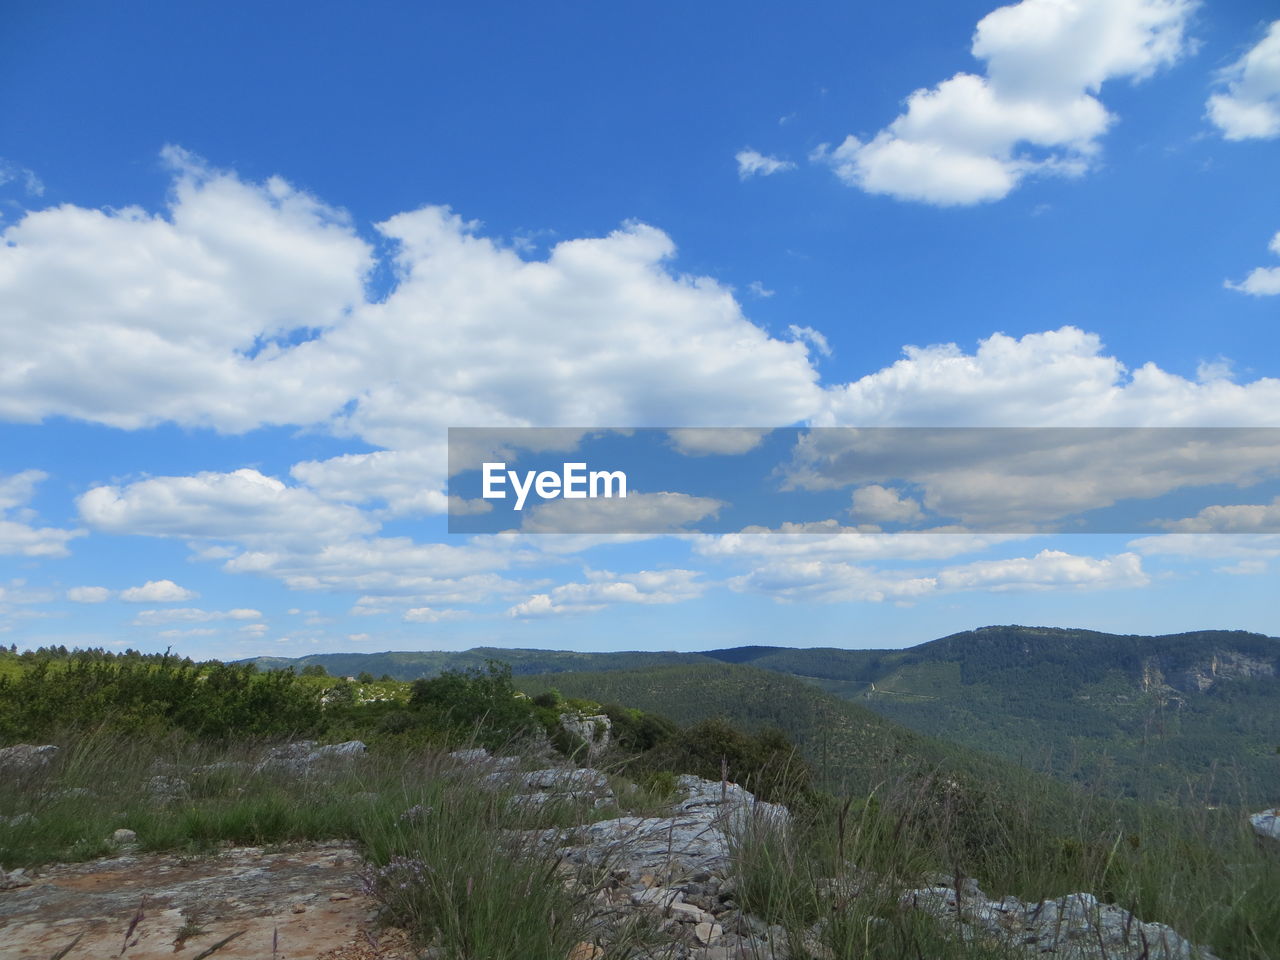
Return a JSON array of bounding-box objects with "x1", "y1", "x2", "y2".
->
[{"x1": 900, "y1": 883, "x2": 1217, "y2": 960}]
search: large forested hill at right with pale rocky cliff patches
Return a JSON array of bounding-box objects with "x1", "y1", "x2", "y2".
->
[{"x1": 707, "y1": 626, "x2": 1280, "y2": 803}]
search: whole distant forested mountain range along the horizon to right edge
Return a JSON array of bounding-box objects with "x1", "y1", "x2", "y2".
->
[{"x1": 241, "y1": 626, "x2": 1280, "y2": 805}]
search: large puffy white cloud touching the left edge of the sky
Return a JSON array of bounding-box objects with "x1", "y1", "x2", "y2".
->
[{"x1": 0, "y1": 148, "x2": 372, "y2": 430}]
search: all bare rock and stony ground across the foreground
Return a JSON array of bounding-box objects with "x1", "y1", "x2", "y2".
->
[{"x1": 0, "y1": 744, "x2": 1275, "y2": 960}]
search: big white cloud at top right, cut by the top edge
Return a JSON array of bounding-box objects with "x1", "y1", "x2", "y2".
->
[{"x1": 814, "y1": 0, "x2": 1196, "y2": 206}]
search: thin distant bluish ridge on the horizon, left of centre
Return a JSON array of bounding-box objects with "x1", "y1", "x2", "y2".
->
[{"x1": 242, "y1": 646, "x2": 712, "y2": 681}]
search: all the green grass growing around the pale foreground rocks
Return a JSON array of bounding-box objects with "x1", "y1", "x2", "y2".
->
[{"x1": 0, "y1": 736, "x2": 1280, "y2": 960}]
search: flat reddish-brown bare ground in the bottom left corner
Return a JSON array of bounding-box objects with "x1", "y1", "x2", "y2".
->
[{"x1": 0, "y1": 842, "x2": 413, "y2": 960}]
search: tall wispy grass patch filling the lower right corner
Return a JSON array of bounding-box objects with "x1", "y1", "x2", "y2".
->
[{"x1": 736, "y1": 769, "x2": 1280, "y2": 960}]
